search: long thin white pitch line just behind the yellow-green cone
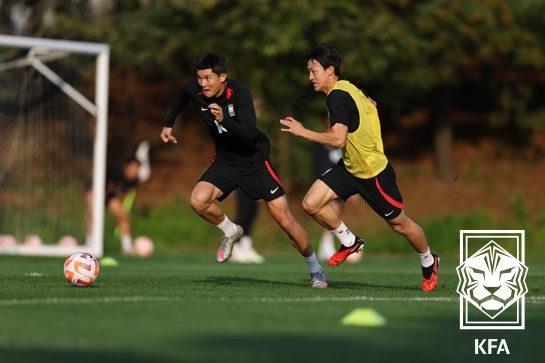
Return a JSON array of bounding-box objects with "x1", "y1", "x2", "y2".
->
[{"x1": 0, "y1": 295, "x2": 545, "y2": 306}]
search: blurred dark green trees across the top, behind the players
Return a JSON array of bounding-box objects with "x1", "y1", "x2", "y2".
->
[{"x1": 0, "y1": 0, "x2": 545, "y2": 180}]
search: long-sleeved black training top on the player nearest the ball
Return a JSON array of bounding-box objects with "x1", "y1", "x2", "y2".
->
[{"x1": 165, "y1": 79, "x2": 271, "y2": 166}]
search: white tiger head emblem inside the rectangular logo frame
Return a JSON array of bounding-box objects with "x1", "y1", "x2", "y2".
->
[{"x1": 456, "y1": 241, "x2": 528, "y2": 319}]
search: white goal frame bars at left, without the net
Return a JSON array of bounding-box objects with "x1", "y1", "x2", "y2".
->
[{"x1": 0, "y1": 34, "x2": 110, "y2": 257}]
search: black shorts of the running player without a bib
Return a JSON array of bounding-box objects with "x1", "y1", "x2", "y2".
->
[{"x1": 199, "y1": 160, "x2": 285, "y2": 202}]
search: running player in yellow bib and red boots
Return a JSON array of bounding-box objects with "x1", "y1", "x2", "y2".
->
[{"x1": 280, "y1": 44, "x2": 439, "y2": 292}]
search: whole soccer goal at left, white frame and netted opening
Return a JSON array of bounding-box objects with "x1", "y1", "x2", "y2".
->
[{"x1": 0, "y1": 34, "x2": 110, "y2": 257}]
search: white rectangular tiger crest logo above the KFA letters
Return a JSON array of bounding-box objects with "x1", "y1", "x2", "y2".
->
[{"x1": 456, "y1": 230, "x2": 528, "y2": 330}]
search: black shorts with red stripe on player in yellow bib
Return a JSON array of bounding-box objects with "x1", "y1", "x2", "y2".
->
[{"x1": 319, "y1": 160, "x2": 404, "y2": 220}]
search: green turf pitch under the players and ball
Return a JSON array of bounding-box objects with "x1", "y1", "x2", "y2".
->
[{"x1": 0, "y1": 254, "x2": 545, "y2": 363}]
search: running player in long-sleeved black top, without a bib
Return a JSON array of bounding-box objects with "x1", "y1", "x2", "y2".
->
[{"x1": 161, "y1": 53, "x2": 327, "y2": 288}]
